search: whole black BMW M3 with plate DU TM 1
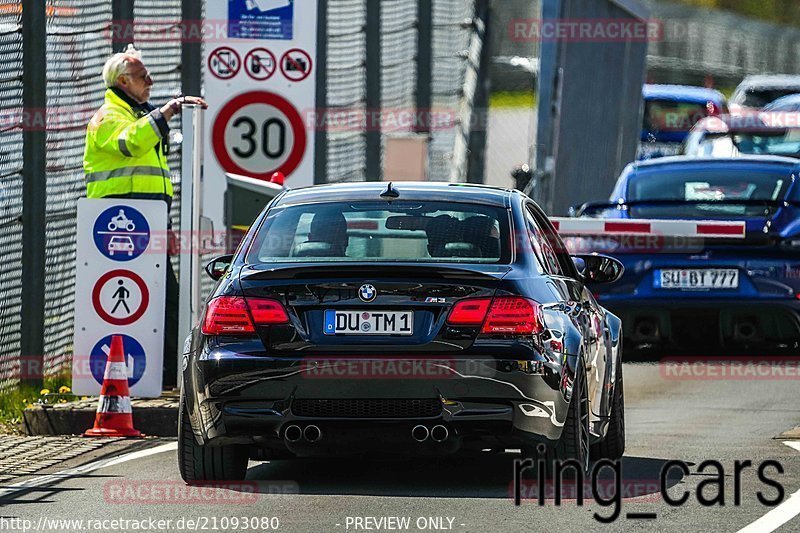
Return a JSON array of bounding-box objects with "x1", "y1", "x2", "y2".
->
[{"x1": 179, "y1": 183, "x2": 625, "y2": 481}]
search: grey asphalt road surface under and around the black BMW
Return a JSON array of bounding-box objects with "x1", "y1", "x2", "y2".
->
[{"x1": 0, "y1": 363, "x2": 800, "y2": 532}]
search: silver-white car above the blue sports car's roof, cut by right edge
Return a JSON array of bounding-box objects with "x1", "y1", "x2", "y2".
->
[{"x1": 681, "y1": 112, "x2": 800, "y2": 158}]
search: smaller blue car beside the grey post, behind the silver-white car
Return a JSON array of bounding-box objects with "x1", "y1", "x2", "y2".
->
[{"x1": 637, "y1": 84, "x2": 728, "y2": 159}]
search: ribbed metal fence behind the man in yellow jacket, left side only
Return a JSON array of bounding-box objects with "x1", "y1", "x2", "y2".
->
[{"x1": 0, "y1": 0, "x2": 181, "y2": 387}]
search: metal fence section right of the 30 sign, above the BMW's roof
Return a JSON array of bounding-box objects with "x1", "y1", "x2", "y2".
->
[{"x1": 319, "y1": 0, "x2": 476, "y2": 182}]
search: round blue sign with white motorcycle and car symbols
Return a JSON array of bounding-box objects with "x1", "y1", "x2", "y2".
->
[{"x1": 94, "y1": 206, "x2": 150, "y2": 261}]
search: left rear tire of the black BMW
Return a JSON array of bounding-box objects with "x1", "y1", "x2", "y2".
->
[{"x1": 178, "y1": 398, "x2": 248, "y2": 483}]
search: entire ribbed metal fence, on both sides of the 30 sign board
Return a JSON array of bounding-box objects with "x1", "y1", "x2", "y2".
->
[{"x1": 0, "y1": 0, "x2": 488, "y2": 388}]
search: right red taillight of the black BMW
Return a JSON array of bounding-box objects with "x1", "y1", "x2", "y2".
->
[{"x1": 447, "y1": 296, "x2": 544, "y2": 335}]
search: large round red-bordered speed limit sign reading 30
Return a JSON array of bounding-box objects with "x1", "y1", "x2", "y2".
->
[{"x1": 211, "y1": 91, "x2": 307, "y2": 180}]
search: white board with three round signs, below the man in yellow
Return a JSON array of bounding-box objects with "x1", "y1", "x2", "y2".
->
[{"x1": 72, "y1": 198, "x2": 169, "y2": 398}]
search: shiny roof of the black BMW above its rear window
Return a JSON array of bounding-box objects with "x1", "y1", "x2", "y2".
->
[{"x1": 275, "y1": 181, "x2": 522, "y2": 207}]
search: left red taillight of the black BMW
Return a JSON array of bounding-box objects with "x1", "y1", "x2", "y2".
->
[{"x1": 201, "y1": 296, "x2": 289, "y2": 335}]
